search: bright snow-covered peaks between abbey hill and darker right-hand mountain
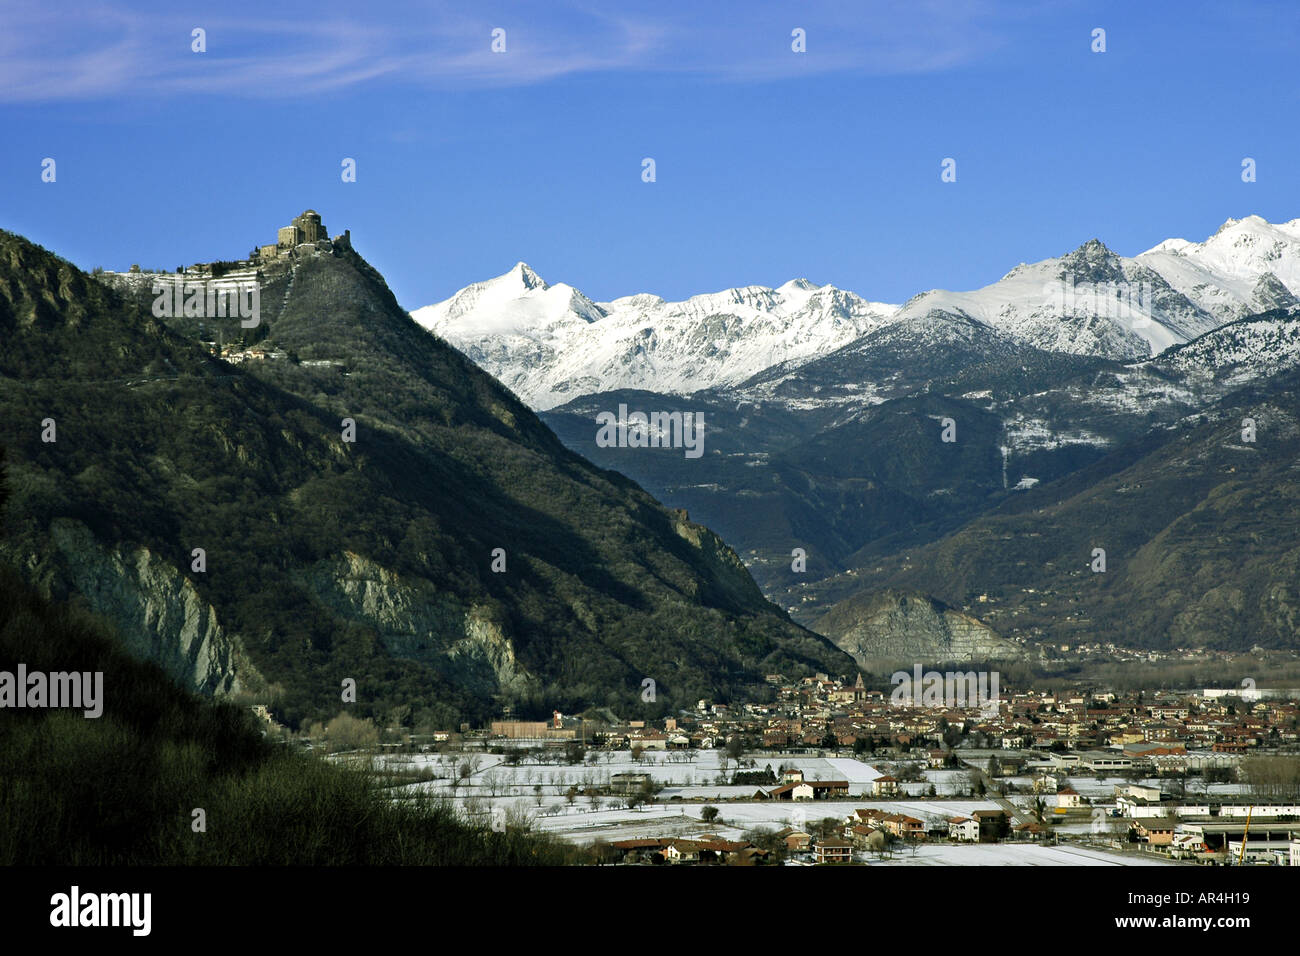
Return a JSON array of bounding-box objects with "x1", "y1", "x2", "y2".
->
[{"x1": 411, "y1": 270, "x2": 897, "y2": 408}]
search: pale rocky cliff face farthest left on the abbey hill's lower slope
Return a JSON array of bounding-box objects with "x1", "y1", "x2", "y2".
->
[{"x1": 43, "y1": 519, "x2": 265, "y2": 695}]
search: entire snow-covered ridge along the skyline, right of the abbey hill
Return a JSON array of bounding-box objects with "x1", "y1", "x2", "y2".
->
[{"x1": 411, "y1": 216, "x2": 1300, "y2": 410}]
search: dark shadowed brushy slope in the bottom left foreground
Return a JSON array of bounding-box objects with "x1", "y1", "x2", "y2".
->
[{"x1": 0, "y1": 566, "x2": 582, "y2": 866}]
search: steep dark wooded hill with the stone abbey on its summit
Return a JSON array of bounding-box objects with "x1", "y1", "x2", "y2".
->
[{"x1": 0, "y1": 223, "x2": 850, "y2": 726}]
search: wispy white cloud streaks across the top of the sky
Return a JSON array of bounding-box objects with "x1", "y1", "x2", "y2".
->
[{"x1": 0, "y1": 0, "x2": 1023, "y2": 101}]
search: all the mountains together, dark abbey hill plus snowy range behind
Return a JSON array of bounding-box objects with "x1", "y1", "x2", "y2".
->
[{"x1": 0, "y1": 217, "x2": 1300, "y2": 727}]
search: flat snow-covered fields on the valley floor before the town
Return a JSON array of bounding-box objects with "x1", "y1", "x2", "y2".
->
[{"x1": 366, "y1": 750, "x2": 1216, "y2": 866}]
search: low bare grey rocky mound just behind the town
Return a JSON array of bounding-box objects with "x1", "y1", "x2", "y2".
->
[{"x1": 815, "y1": 591, "x2": 1024, "y2": 666}]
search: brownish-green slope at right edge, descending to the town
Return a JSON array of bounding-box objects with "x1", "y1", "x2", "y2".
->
[{"x1": 816, "y1": 372, "x2": 1300, "y2": 649}]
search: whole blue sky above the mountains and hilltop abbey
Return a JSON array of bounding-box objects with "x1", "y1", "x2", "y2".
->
[{"x1": 0, "y1": 0, "x2": 1300, "y2": 308}]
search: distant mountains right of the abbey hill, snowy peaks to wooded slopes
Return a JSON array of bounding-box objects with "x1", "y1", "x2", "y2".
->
[{"x1": 415, "y1": 216, "x2": 1300, "y2": 662}]
